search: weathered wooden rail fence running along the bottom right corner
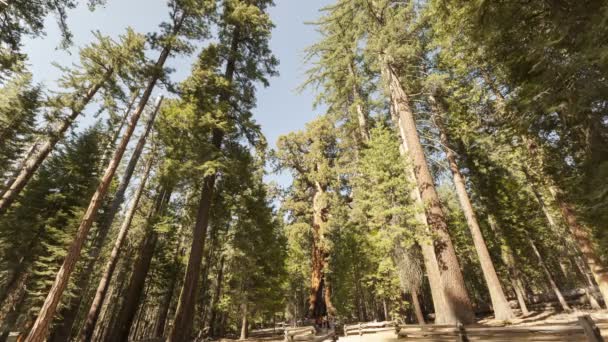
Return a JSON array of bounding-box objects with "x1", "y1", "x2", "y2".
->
[{"x1": 395, "y1": 315, "x2": 608, "y2": 342}]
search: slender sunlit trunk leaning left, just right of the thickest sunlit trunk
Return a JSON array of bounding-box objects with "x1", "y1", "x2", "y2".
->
[{"x1": 429, "y1": 95, "x2": 515, "y2": 320}]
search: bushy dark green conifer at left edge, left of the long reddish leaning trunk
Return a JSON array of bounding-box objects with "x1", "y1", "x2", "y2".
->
[{"x1": 0, "y1": 126, "x2": 102, "y2": 340}]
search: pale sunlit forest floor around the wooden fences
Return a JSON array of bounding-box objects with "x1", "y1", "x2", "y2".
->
[{"x1": 239, "y1": 310, "x2": 608, "y2": 342}]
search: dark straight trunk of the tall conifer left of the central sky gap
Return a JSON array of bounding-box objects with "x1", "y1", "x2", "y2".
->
[{"x1": 167, "y1": 27, "x2": 240, "y2": 342}]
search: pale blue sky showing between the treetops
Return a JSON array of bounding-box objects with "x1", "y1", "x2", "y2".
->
[{"x1": 24, "y1": 0, "x2": 333, "y2": 150}]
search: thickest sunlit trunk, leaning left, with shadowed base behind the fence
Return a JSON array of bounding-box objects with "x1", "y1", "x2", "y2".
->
[{"x1": 383, "y1": 61, "x2": 475, "y2": 324}]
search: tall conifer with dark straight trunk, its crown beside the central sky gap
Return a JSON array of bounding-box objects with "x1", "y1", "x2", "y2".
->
[{"x1": 168, "y1": 0, "x2": 277, "y2": 342}]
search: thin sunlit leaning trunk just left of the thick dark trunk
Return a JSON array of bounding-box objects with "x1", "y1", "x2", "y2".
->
[{"x1": 78, "y1": 155, "x2": 154, "y2": 341}]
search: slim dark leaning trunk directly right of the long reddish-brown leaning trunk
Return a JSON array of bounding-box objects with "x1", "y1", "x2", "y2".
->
[{"x1": 49, "y1": 96, "x2": 163, "y2": 342}]
